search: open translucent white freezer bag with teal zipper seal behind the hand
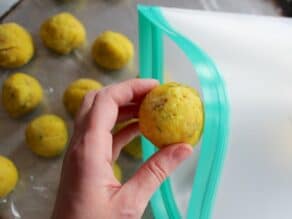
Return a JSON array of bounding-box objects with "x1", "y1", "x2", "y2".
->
[{"x1": 138, "y1": 6, "x2": 292, "y2": 219}]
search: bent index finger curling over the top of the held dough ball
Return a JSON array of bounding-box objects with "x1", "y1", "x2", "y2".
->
[{"x1": 87, "y1": 79, "x2": 158, "y2": 161}]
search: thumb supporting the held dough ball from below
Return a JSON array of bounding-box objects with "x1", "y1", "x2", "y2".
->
[{"x1": 121, "y1": 144, "x2": 193, "y2": 208}]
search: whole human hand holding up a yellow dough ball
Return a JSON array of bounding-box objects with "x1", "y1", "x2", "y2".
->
[{"x1": 52, "y1": 79, "x2": 192, "y2": 219}]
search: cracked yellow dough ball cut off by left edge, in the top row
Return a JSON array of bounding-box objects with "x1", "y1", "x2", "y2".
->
[{"x1": 0, "y1": 23, "x2": 34, "y2": 68}]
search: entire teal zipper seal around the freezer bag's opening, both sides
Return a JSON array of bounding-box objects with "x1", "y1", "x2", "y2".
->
[{"x1": 138, "y1": 6, "x2": 229, "y2": 219}]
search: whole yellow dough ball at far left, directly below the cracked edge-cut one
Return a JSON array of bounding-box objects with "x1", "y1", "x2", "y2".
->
[{"x1": 2, "y1": 72, "x2": 43, "y2": 118}]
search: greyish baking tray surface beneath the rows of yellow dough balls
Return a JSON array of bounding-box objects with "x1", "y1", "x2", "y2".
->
[{"x1": 0, "y1": 0, "x2": 279, "y2": 219}]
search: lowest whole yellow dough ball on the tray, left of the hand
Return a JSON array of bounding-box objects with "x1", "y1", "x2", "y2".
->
[{"x1": 25, "y1": 114, "x2": 68, "y2": 157}]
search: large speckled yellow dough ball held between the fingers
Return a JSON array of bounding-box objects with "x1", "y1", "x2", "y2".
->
[{"x1": 139, "y1": 82, "x2": 203, "y2": 148}]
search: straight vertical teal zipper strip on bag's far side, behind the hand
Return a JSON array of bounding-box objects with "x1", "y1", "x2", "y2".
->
[{"x1": 139, "y1": 8, "x2": 181, "y2": 219}]
